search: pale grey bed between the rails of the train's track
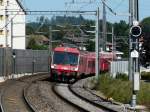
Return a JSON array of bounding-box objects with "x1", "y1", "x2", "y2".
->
[{"x1": 54, "y1": 84, "x2": 108, "y2": 112}]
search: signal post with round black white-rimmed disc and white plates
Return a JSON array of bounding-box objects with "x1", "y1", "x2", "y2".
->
[{"x1": 130, "y1": 21, "x2": 142, "y2": 108}]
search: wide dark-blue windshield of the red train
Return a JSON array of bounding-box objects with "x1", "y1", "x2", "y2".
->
[{"x1": 53, "y1": 52, "x2": 78, "y2": 66}]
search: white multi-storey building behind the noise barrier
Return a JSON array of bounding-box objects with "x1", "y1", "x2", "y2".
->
[{"x1": 0, "y1": 0, "x2": 26, "y2": 49}]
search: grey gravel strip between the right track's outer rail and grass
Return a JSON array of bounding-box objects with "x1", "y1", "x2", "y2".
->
[{"x1": 69, "y1": 79, "x2": 127, "y2": 112}]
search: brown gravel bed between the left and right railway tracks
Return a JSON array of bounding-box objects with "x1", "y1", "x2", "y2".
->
[{"x1": 26, "y1": 82, "x2": 80, "y2": 112}]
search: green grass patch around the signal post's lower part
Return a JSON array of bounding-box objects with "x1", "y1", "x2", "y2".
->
[{"x1": 95, "y1": 74, "x2": 150, "y2": 108}]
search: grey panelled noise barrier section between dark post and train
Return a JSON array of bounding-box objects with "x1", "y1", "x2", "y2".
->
[{"x1": 13, "y1": 50, "x2": 49, "y2": 73}]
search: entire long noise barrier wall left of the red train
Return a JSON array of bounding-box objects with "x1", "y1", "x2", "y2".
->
[{"x1": 0, "y1": 48, "x2": 49, "y2": 76}]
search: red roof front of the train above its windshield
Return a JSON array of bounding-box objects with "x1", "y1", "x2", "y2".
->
[{"x1": 54, "y1": 47, "x2": 80, "y2": 54}]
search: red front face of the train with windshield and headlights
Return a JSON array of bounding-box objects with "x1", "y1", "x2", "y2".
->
[{"x1": 51, "y1": 47, "x2": 79, "y2": 82}]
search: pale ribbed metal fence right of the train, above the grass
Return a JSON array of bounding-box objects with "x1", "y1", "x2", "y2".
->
[{"x1": 110, "y1": 60, "x2": 128, "y2": 77}]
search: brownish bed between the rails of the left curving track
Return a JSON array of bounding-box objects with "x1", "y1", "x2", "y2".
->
[{"x1": 0, "y1": 74, "x2": 48, "y2": 112}]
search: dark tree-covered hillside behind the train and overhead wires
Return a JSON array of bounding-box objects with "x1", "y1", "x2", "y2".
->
[{"x1": 26, "y1": 15, "x2": 129, "y2": 56}]
